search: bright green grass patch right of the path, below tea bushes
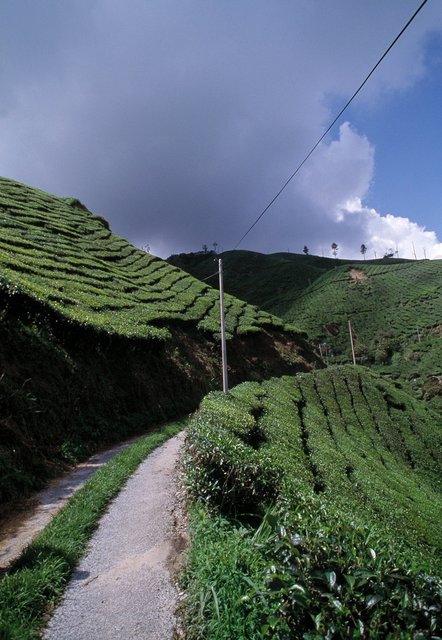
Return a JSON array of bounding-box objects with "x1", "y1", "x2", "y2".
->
[{"x1": 181, "y1": 505, "x2": 271, "y2": 640}]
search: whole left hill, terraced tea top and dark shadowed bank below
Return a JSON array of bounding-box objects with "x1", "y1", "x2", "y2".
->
[{"x1": 0, "y1": 178, "x2": 322, "y2": 510}]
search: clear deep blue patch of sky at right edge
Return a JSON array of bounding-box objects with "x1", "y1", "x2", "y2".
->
[{"x1": 347, "y1": 28, "x2": 442, "y2": 238}]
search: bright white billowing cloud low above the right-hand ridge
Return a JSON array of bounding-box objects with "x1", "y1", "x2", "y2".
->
[{"x1": 295, "y1": 122, "x2": 442, "y2": 259}]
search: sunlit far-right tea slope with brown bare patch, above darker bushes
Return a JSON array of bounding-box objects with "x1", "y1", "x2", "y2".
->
[{"x1": 285, "y1": 260, "x2": 442, "y2": 355}]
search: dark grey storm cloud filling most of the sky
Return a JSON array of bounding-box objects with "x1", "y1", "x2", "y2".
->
[{"x1": 0, "y1": 0, "x2": 440, "y2": 255}]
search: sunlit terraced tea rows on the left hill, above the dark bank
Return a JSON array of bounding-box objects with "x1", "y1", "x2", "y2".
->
[{"x1": 0, "y1": 178, "x2": 284, "y2": 338}]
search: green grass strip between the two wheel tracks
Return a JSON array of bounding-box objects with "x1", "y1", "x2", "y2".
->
[{"x1": 0, "y1": 421, "x2": 186, "y2": 640}]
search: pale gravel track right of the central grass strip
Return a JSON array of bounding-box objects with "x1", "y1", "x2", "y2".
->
[{"x1": 44, "y1": 433, "x2": 185, "y2": 640}]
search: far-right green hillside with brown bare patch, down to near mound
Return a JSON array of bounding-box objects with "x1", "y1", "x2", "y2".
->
[{"x1": 284, "y1": 260, "x2": 442, "y2": 407}]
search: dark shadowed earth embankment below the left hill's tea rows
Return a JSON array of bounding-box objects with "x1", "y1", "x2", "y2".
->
[{"x1": 0, "y1": 292, "x2": 321, "y2": 513}]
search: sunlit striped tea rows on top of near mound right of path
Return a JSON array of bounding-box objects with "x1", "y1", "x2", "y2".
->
[{"x1": 187, "y1": 367, "x2": 442, "y2": 550}]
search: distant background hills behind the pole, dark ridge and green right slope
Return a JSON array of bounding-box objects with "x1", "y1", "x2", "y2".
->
[{"x1": 170, "y1": 251, "x2": 442, "y2": 407}]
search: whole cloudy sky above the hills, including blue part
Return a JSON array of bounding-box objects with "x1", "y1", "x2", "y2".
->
[{"x1": 0, "y1": 0, "x2": 442, "y2": 259}]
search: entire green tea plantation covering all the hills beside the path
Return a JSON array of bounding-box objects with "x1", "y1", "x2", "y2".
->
[{"x1": 0, "y1": 178, "x2": 442, "y2": 640}]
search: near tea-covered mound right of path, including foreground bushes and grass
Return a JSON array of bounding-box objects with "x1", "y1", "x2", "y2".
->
[{"x1": 183, "y1": 366, "x2": 442, "y2": 639}]
